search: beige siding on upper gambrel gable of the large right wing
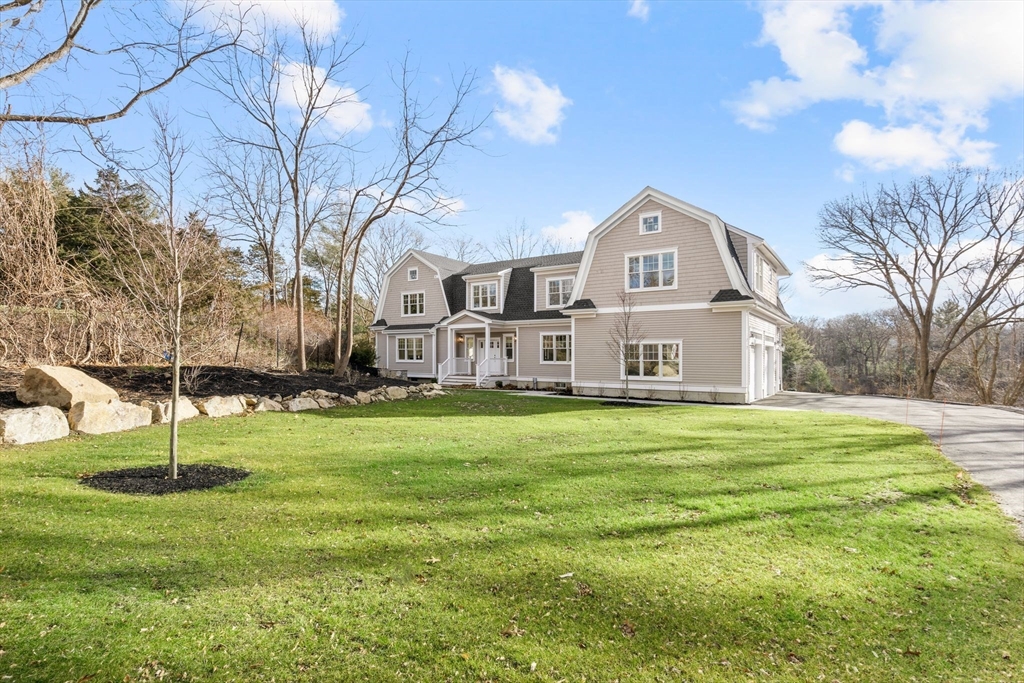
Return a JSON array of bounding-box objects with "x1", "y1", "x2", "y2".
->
[{"x1": 581, "y1": 200, "x2": 732, "y2": 308}]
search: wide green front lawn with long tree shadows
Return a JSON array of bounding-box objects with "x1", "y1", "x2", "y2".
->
[{"x1": 0, "y1": 392, "x2": 1024, "y2": 682}]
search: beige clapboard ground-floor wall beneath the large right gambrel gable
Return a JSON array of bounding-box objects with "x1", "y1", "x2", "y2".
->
[{"x1": 575, "y1": 308, "x2": 742, "y2": 386}]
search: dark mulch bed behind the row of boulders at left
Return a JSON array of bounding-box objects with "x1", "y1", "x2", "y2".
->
[{"x1": 0, "y1": 366, "x2": 411, "y2": 410}]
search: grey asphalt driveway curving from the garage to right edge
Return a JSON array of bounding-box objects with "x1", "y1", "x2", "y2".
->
[{"x1": 755, "y1": 391, "x2": 1024, "y2": 523}]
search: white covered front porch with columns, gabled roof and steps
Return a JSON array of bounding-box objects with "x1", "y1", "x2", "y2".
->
[{"x1": 437, "y1": 313, "x2": 517, "y2": 387}]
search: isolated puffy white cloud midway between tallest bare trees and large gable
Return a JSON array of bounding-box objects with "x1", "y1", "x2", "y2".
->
[{"x1": 493, "y1": 65, "x2": 572, "y2": 144}]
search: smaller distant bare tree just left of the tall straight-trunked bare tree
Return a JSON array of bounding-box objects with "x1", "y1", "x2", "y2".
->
[{"x1": 207, "y1": 144, "x2": 288, "y2": 310}]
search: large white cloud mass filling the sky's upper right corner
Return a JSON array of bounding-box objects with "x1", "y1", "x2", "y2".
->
[{"x1": 733, "y1": 0, "x2": 1024, "y2": 169}]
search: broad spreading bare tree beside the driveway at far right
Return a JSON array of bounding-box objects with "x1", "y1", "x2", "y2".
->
[{"x1": 808, "y1": 167, "x2": 1024, "y2": 398}]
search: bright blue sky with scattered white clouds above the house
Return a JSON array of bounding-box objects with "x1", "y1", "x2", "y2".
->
[{"x1": 9, "y1": 0, "x2": 1024, "y2": 315}]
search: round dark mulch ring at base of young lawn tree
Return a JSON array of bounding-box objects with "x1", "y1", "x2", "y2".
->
[{"x1": 79, "y1": 465, "x2": 251, "y2": 496}]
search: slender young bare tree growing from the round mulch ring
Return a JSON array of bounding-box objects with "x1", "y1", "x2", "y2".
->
[{"x1": 101, "y1": 112, "x2": 222, "y2": 479}]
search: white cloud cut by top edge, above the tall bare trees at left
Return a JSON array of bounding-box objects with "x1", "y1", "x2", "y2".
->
[{"x1": 193, "y1": 0, "x2": 345, "y2": 36}]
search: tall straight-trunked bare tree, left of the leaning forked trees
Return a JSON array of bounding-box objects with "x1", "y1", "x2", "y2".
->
[{"x1": 203, "y1": 22, "x2": 359, "y2": 371}]
